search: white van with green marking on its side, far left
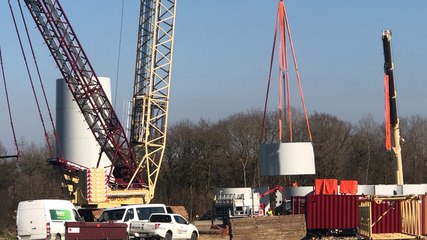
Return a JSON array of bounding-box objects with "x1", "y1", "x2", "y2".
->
[{"x1": 16, "y1": 199, "x2": 81, "y2": 240}]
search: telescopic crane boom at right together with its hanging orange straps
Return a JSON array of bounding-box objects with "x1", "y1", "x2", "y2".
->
[{"x1": 382, "y1": 30, "x2": 404, "y2": 185}]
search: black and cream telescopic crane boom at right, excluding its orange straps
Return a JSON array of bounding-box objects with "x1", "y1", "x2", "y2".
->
[{"x1": 382, "y1": 30, "x2": 404, "y2": 185}]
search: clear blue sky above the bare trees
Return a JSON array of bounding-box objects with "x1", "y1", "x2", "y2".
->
[{"x1": 0, "y1": 0, "x2": 427, "y2": 152}]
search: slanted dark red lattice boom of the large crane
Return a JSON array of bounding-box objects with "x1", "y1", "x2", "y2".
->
[{"x1": 25, "y1": 0, "x2": 143, "y2": 187}]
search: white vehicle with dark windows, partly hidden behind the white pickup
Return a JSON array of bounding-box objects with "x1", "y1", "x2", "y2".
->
[{"x1": 98, "y1": 204, "x2": 167, "y2": 228}]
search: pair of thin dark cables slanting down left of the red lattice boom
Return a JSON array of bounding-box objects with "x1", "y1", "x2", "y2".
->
[{"x1": 8, "y1": 0, "x2": 59, "y2": 157}]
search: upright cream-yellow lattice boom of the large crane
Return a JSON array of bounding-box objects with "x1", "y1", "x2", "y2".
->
[{"x1": 130, "y1": 0, "x2": 176, "y2": 201}]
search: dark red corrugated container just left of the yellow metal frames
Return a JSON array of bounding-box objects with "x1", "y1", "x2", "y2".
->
[{"x1": 306, "y1": 195, "x2": 359, "y2": 230}]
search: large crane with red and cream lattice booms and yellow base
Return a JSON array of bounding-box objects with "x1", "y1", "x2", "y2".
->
[{"x1": 25, "y1": 0, "x2": 175, "y2": 206}]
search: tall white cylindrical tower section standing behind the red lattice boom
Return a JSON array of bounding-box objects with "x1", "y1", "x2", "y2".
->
[{"x1": 56, "y1": 77, "x2": 111, "y2": 168}]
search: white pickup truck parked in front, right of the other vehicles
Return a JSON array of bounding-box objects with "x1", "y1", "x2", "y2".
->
[{"x1": 129, "y1": 213, "x2": 199, "y2": 240}]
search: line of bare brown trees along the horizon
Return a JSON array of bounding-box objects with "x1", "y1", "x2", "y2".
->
[{"x1": 0, "y1": 110, "x2": 427, "y2": 234}]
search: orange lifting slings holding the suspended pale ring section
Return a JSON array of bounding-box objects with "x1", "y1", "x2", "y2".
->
[{"x1": 262, "y1": 0, "x2": 313, "y2": 142}]
